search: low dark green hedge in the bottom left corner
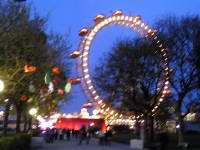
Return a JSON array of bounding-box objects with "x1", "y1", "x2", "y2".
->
[{"x1": 0, "y1": 134, "x2": 31, "y2": 150}]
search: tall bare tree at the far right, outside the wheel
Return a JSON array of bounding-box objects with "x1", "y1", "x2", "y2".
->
[{"x1": 157, "y1": 16, "x2": 200, "y2": 142}]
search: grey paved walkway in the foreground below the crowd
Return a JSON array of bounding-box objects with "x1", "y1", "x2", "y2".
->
[{"x1": 37, "y1": 139, "x2": 131, "y2": 150}]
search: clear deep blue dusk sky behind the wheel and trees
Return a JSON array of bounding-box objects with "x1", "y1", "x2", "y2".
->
[{"x1": 30, "y1": 0, "x2": 200, "y2": 112}]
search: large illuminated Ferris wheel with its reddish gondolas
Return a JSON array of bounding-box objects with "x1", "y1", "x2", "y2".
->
[{"x1": 70, "y1": 10, "x2": 170, "y2": 126}]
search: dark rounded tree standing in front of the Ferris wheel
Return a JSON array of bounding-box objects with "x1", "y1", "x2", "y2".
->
[{"x1": 95, "y1": 38, "x2": 164, "y2": 142}]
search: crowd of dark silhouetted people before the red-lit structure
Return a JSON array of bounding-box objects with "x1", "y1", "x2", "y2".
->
[{"x1": 44, "y1": 126, "x2": 112, "y2": 145}]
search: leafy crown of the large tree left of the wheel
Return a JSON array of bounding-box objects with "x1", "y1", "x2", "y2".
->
[{"x1": 0, "y1": 0, "x2": 69, "y2": 110}]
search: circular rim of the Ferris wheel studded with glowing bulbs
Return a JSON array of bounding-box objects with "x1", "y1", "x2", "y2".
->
[{"x1": 76, "y1": 11, "x2": 170, "y2": 118}]
